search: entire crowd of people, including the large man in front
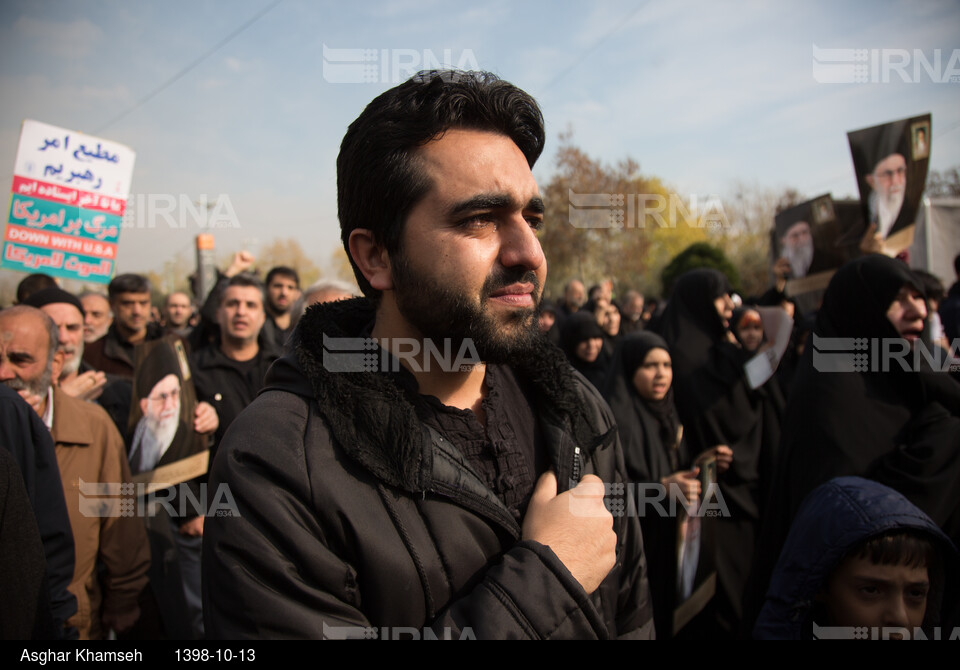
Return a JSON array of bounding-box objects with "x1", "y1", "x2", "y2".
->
[{"x1": 0, "y1": 72, "x2": 960, "y2": 640}]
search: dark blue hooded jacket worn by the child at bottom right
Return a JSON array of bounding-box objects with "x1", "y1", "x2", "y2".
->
[{"x1": 753, "y1": 477, "x2": 960, "y2": 640}]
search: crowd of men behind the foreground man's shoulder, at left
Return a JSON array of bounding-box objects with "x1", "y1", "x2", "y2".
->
[{"x1": 0, "y1": 252, "x2": 355, "y2": 640}]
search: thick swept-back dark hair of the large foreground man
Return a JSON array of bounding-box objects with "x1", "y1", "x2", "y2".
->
[{"x1": 337, "y1": 70, "x2": 545, "y2": 300}]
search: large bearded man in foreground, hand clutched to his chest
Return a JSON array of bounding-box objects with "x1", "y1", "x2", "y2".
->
[{"x1": 203, "y1": 72, "x2": 652, "y2": 638}]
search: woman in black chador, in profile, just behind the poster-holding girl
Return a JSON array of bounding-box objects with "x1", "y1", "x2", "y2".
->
[{"x1": 658, "y1": 269, "x2": 783, "y2": 637}]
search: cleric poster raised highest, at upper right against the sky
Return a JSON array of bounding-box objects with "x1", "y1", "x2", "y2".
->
[{"x1": 847, "y1": 114, "x2": 931, "y2": 256}]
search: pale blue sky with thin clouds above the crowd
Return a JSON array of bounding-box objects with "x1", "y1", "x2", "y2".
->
[{"x1": 0, "y1": 0, "x2": 960, "y2": 272}]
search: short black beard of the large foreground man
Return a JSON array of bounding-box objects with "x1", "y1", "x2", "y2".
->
[{"x1": 393, "y1": 251, "x2": 543, "y2": 364}]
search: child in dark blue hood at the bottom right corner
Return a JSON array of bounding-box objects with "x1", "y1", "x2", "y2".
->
[{"x1": 754, "y1": 477, "x2": 960, "y2": 640}]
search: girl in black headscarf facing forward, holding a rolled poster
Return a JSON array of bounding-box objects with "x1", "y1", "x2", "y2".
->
[{"x1": 604, "y1": 332, "x2": 732, "y2": 639}]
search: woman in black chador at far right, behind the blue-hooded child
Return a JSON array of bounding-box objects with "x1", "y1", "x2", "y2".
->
[{"x1": 750, "y1": 254, "x2": 960, "y2": 636}]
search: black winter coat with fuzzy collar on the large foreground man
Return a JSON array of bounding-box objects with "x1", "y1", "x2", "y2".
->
[{"x1": 203, "y1": 299, "x2": 653, "y2": 639}]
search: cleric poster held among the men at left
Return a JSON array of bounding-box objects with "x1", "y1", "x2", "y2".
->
[{"x1": 128, "y1": 336, "x2": 210, "y2": 493}]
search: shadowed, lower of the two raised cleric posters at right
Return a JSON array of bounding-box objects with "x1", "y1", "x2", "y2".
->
[{"x1": 770, "y1": 194, "x2": 849, "y2": 309}]
